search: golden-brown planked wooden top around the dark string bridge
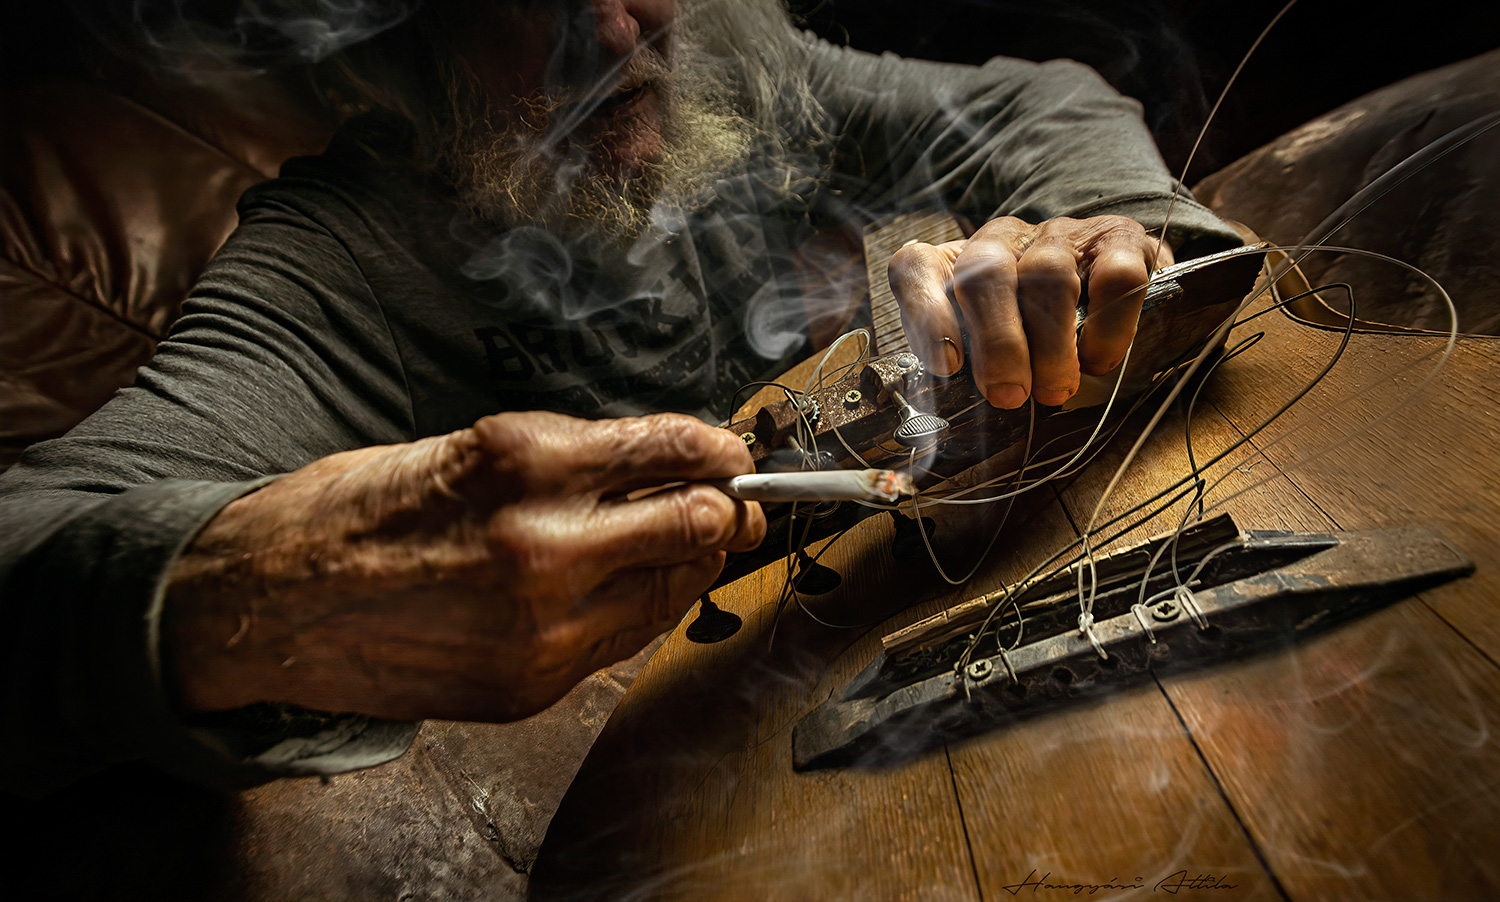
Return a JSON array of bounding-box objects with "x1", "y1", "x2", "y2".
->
[{"x1": 531, "y1": 304, "x2": 1500, "y2": 900}]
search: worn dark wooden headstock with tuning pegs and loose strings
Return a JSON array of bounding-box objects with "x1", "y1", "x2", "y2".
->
[{"x1": 719, "y1": 210, "x2": 1266, "y2": 584}]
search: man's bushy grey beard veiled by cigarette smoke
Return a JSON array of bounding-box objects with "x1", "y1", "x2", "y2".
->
[{"x1": 443, "y1": 41, "x2": 756, "y2": 246}]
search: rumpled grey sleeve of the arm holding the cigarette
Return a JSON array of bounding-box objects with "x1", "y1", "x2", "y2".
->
[{"x1": 0, "y1": 186, "x2": 416, "y2": 794}]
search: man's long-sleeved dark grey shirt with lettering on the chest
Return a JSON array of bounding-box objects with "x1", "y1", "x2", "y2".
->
[{"x1": 0, "y1": 36, "x2": 1238, "y2": 794}]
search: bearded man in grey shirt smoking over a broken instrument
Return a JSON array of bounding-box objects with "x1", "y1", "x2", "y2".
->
[{"x1": 0, "y1": 0, "x2": 1236, "y2": 792}]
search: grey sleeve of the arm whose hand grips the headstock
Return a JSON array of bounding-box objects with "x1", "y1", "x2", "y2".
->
[{"x1": 809, "y1": 42, "x2": 1241, "y2": 258}]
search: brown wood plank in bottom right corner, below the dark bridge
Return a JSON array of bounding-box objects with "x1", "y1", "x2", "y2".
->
[{"x1": 1164, "y1": 591, "x2": 1500, "y2": 900}]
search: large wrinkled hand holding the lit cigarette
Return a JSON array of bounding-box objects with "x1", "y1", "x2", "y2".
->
[{"x1": 162, "y1": 413, "x2": 765, "y2": 720}]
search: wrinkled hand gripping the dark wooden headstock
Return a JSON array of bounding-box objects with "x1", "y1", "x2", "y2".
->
[{"x1": 890, "y1": 216, "x2": 1173, "y2": 408}]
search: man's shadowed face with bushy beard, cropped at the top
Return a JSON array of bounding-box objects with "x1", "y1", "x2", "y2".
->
[{"x1": 449, "y1": 0, "x2": 749, "y2": 237}]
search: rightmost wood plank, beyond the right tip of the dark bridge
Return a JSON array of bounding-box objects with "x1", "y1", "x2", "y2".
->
[{"x1": 1211, "y1": 320, "x2": 1500, "y2": 660}]
